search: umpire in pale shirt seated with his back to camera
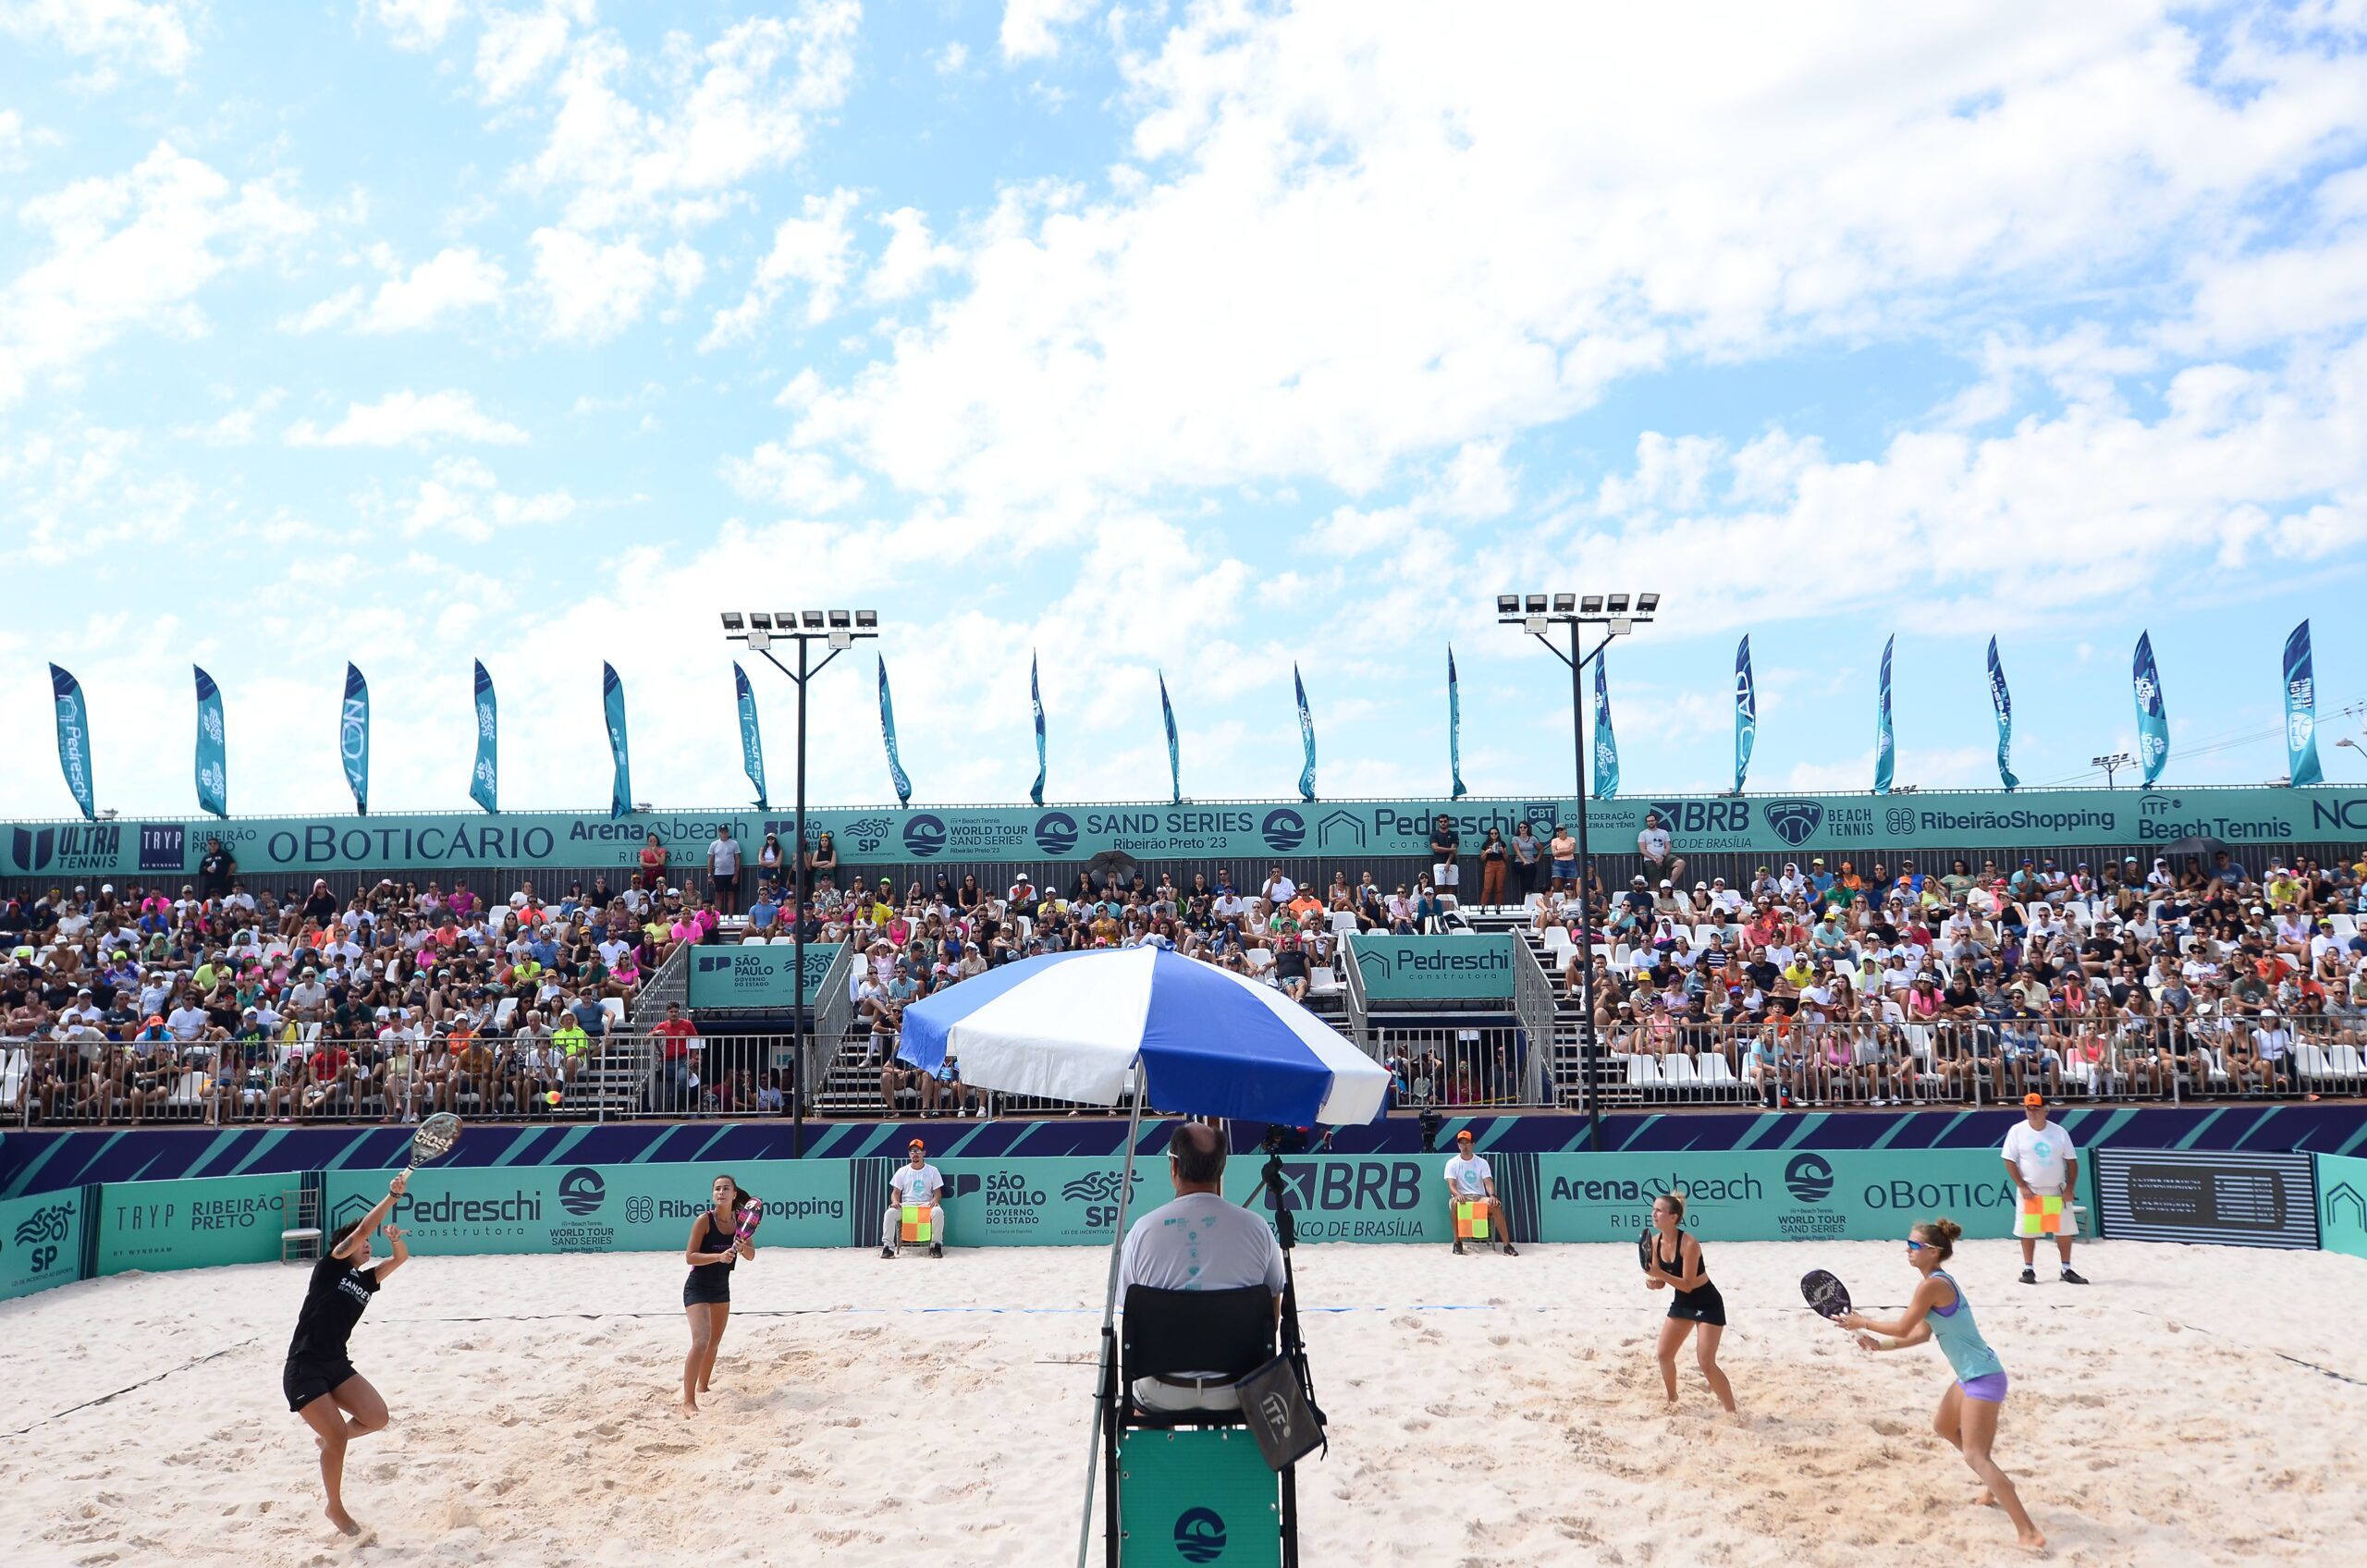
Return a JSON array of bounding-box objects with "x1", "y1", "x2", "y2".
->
[{"x1": 1117, "y1": 1122, "x2": 1283, "y2": 1412}]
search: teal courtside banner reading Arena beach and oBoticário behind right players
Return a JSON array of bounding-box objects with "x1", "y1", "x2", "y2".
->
[{"x1": 1536, "y1": 1149, "x2": 2035, "y2": 1241}]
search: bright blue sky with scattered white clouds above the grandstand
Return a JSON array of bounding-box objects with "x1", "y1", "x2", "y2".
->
[{"x1": 0, "y1": 0, "x2": 2367, "y2": 817}]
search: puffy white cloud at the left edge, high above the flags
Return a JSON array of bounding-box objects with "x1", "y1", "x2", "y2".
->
[{"x1": 0, "y1": 142, "x2": 313, "y2": 408}]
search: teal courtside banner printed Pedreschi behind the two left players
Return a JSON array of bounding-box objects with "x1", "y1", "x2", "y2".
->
[{"x1": 326, "y1": 1160, "x2": 852, "y2": 1256}]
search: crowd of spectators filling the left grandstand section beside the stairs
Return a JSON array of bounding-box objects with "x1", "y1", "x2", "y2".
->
[{"x1": 0, "y1": 846, "x2": 719, "y2": 1121}]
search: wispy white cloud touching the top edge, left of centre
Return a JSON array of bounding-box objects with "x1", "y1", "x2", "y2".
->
[{"x1": 530, "y1": 0, "x2": 862, "y2": 230}]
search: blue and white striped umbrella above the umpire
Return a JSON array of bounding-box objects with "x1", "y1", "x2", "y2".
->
[{"x1": 897, "y1": 948, "x2": 1390, "y2": 1125}]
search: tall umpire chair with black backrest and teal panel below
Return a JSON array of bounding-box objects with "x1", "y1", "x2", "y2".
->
[{"x1": 1098, "y1": 1284, "x2": 1311, "y2": 1568}]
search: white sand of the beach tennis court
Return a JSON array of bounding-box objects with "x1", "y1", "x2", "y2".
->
[{"x1": 0, "y1": 1239, "x2": 2367, "y2": 1568}]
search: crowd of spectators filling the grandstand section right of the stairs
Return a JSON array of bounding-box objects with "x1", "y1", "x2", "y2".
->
[{"x1": 1534, "y1": 851, "x2": 2367, "y2": 1106}]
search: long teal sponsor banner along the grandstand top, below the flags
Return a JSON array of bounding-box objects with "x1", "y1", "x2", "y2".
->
[{"x1": 0, "y1": 784, "x2": 2367, "y2": 878}]
